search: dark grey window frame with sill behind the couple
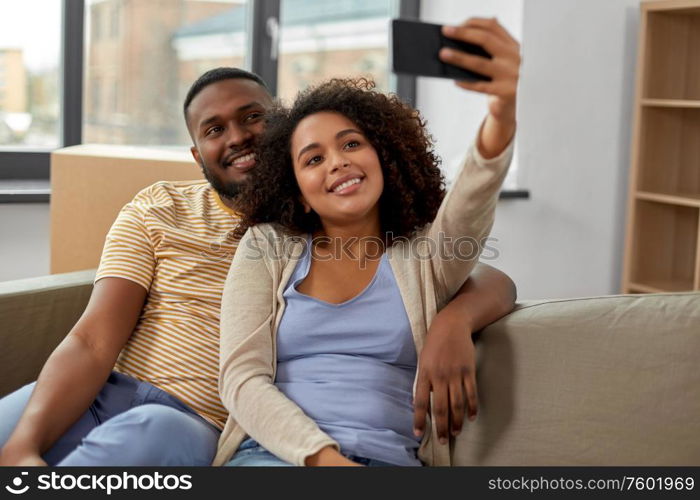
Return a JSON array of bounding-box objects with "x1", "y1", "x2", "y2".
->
[{"x1": 0, "y1": 0, "x2": 420, "y2": 184}]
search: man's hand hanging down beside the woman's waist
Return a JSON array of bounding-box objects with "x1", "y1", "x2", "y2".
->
[{"x1": 413, "y1": 313, "x2": 478, "y2": 444}]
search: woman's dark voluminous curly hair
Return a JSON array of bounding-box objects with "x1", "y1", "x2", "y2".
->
[{"x1": 236, "y1": 78, "x2": 445, "y2": 244}]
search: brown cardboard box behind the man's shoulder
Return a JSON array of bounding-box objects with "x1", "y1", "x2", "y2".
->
[{"x1": 51, "y1": 144, "x2": 204, "y2": 274}]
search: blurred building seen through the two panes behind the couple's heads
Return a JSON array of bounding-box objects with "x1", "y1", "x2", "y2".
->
[{"x1": 83, "y1": 0, "x2": 395, "y2": 145}]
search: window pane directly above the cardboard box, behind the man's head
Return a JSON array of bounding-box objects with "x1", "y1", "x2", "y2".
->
[{"x1": 83, "y1": 0, "x2": 247, "y2": 145}]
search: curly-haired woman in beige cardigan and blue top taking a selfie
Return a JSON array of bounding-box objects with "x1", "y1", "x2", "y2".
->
[{"x1": 215, "y1": 20, "x2": 517, "y2": 465}]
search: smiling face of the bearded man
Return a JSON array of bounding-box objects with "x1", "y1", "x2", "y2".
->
[{"x1": 187, "y1": 78, "x2": 272, "y2": 198}]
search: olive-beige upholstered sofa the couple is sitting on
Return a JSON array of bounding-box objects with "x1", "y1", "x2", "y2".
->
[{"x1": 0, "y1": 271, "x2": 700, "y2": 466}]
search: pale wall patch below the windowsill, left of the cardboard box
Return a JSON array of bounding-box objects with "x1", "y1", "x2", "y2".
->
[{"x1": 0, "y1": 203, "x2": 50, "y2": 282}]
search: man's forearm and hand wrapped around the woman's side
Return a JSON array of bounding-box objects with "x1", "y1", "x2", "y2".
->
[{"x1": 414, "y1": 263, "x2": 517, "y2": 444}]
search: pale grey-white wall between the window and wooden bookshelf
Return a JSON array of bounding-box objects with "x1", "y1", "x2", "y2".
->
[{"x1": 418, "y1": 0, "x2": 639, "y2": 299}]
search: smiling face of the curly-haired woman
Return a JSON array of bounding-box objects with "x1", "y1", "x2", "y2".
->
[{"x1": 291, "y1": 111, "x2": 384, "y2": 229}]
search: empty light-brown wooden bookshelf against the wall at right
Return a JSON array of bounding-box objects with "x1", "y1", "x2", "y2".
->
[{"x1": 622, "y1": 0, "x2": 700, "y2": 293}]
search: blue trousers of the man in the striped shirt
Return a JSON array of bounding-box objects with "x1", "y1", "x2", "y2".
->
[{"x1": 0, "y1": 372, "x2": 220, "y2": 466}]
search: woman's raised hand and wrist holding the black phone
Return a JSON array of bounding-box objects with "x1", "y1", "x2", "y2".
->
[{"x1": 440, "y1": 18, "x2": 521, "y2": 158}]
